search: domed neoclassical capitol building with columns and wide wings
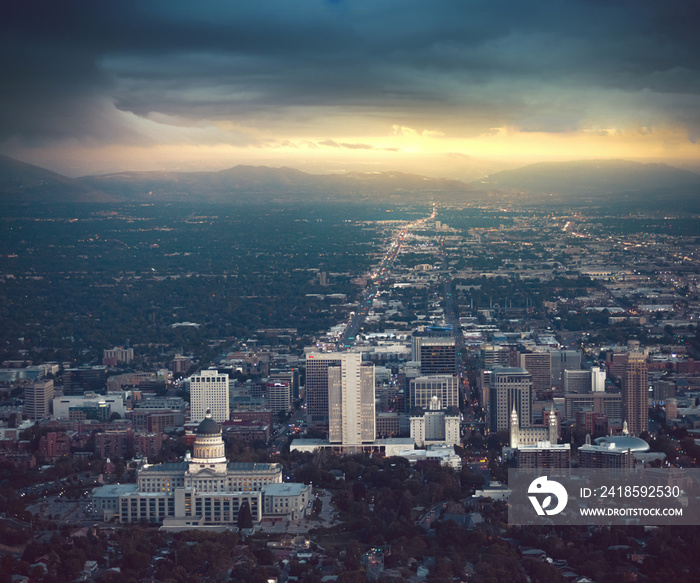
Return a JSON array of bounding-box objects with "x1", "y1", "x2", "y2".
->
[{"x1": 92, "y1": 412, "x2": 311, "y2": 529}]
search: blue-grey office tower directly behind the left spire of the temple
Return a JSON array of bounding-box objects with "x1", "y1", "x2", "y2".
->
[{"x1": 487, "y1": 367, "x2": 533, "y2": 432}]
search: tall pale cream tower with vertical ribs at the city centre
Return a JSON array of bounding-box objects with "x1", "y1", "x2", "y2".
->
[{"x1": 328, "y1": 352, "x2": 376, "y2": 446}]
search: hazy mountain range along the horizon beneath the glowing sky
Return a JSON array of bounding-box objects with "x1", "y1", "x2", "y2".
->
[{"x1": 0, "y1": 156, "x2": 700, "y2": 213}]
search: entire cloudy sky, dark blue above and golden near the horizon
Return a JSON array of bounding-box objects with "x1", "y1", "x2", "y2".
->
[{"x1": 0, "y1": 0, "x2": 700, "y2": 180}]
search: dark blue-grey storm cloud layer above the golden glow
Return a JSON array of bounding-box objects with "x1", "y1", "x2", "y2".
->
[{"x1": 0, "y1": 0, "x2": 700, "y2": 147}]
